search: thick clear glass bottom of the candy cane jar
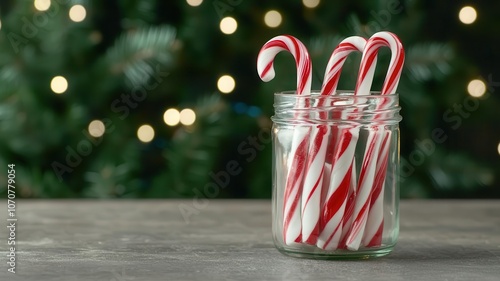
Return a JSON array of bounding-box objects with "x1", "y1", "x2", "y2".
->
[{"x1": 277, "y1": 246, "x2": 394, "y2": 260}]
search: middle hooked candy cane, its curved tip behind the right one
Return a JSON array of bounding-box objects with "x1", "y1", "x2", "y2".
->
[{"x1": 317, "y1": 36, "x2": 374, "y2": 250}]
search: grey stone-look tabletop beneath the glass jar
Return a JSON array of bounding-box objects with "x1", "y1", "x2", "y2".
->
[{"x1": 0, "y1": 200, "x2": 500, "y2": 281}]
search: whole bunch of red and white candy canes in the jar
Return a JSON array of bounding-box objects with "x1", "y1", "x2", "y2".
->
[{"x1": 257, "y1": 32, "x2": 404, "y2": 251}]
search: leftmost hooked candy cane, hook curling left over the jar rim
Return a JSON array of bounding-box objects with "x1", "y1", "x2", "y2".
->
[{"x1": 257, "y1": 35, "x2": 312, "y2": 245}]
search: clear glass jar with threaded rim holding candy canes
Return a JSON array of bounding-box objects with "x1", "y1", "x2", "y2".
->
[{"x1": 271, "y1": 91, "x2": 401, "y2": 259}]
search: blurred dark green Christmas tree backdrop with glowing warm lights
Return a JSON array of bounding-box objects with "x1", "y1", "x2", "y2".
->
[{"x1": 0, "y1": 0, "x2": 500, "y2": 198}]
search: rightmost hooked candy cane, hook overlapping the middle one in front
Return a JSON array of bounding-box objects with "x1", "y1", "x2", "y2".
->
[{"x1": 346, "y1": 32, "x2": 404, "y2": 250}]
